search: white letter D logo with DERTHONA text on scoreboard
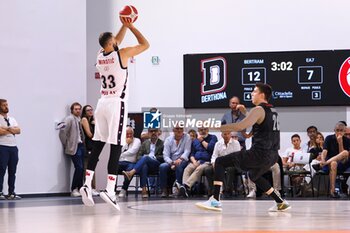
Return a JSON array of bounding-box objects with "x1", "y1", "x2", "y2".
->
[{"x1": 201, "y1": 57, "x2": 227, "y2": 103}]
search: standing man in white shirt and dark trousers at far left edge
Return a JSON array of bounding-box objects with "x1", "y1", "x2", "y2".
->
[{"x1": 0, "y1": 99, "x2": 21, "y2": 200}]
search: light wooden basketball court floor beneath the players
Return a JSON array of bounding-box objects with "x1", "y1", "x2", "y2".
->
[{"x1": 0, "y1": 197, "x2": 350, "y2": 233}]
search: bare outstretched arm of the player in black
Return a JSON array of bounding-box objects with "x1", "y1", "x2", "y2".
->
[{"x1": 220, "y1": 106, "x2": 265, "y2": 131}]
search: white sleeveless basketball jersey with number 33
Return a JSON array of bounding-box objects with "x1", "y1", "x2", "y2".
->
[{"x1": 96, "y1": 48, "x2": 128, "y2": 100}]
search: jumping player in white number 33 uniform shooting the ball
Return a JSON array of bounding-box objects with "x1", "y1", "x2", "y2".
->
[{"x1": 80, "y1": 17, "x2": 149, "y2": 210}]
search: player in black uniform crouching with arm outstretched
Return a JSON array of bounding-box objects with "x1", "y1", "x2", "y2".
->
[{"x1": 196, "y1": 83, "x2": 291, "y2": 211}]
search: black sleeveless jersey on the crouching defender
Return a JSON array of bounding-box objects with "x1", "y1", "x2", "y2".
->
[{"x1": 251, "y1": 103, "x2": 280, "y2": 151}]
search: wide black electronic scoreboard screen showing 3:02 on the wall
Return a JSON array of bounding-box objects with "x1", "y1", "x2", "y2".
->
[{"x1": 184, "y1": 50, "x2": 350, "y2": 108}]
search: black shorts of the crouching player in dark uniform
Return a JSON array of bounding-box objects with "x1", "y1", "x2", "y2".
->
[{"x1": 215, "y1": 150, "x2": 279, "y2": 181}]
